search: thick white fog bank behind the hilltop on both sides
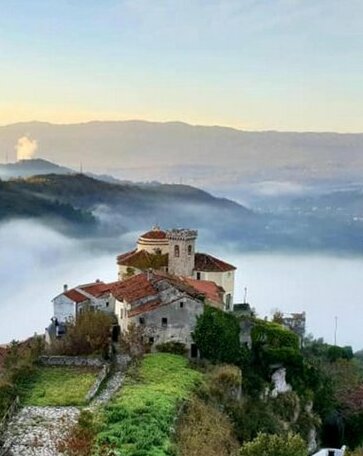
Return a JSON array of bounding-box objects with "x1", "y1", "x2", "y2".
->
[{"x1": 0, "y1": 221, "x2": 363, "y2": 350}]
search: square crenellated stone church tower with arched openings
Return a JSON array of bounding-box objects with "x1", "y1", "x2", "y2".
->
[{"x1": 166, "y1": 229, "x2": 198, "y2": 277}]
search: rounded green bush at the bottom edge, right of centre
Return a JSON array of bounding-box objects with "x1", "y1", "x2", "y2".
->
[{"x1": 240, "y1": 433, "x2": 308, "y2": 456}]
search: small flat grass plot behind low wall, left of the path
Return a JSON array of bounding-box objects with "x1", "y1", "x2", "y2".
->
[{"x1": 22, "y1": 367, "x2": 97, "y2": 406}]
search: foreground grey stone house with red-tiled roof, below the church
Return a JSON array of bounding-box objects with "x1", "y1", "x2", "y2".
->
[{"x1": 111, "y1": 271, "x2": 223, "y2": 356}]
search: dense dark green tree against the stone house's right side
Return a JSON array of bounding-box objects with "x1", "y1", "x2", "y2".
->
[{"x1": 193, "y1": 306, "x2": 240, "y2": 364}]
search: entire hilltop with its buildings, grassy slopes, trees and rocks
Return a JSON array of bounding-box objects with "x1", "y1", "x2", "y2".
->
[{"x1": 0, "y1": 226, "x2": 363, "y2": 456}]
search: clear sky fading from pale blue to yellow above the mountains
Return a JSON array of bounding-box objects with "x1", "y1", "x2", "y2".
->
[{"x1": 0, "y1": 0, "x2": 363, "y2": 132}]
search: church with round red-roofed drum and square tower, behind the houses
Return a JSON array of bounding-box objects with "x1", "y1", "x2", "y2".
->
[{"x1": 117, "y1": 226, "x2": 236, "y2": 310}]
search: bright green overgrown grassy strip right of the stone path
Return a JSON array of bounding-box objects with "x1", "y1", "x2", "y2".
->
[{"x1": 99, "y1": 353, "x2": 201, "y2": 456}]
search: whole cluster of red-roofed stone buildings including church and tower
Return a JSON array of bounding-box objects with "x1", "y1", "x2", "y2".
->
[{"x1": 47, "y1": 226, "x2": 236, "y2": 356}]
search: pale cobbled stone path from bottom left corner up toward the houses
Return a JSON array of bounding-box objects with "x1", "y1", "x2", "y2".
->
[{"x1": 0, "y1": 371, "x2": 124, "y2": 456}]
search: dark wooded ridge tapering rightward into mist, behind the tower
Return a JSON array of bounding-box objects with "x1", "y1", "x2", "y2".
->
[{"x1": 0, "y1": 174, "x2": 259, "y2": 244}]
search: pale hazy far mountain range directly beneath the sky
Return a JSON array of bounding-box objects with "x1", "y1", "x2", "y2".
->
[{"x1": 0, "y1": 121, "x2": 363, "y2": 188}]
